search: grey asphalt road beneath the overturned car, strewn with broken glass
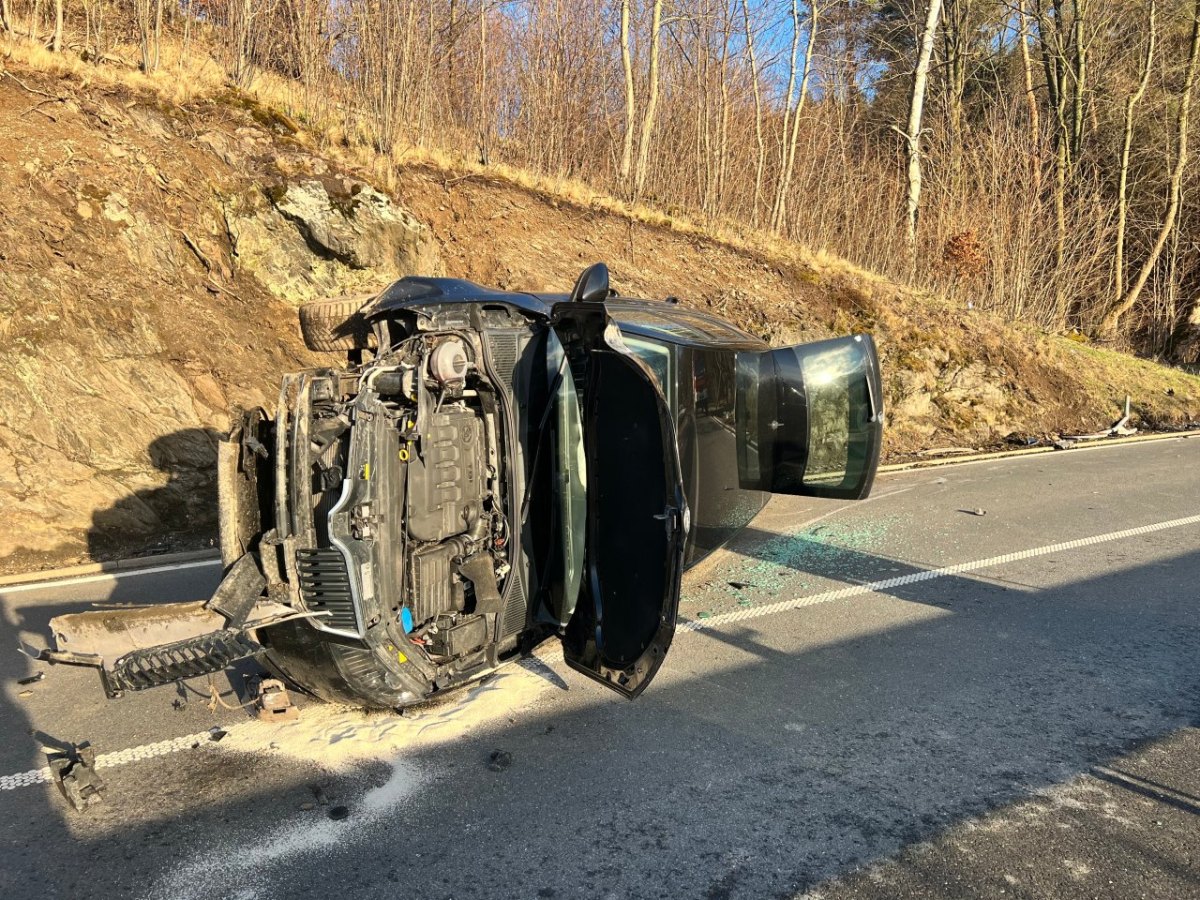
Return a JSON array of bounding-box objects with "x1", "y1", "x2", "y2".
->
[{"x1": 0, "y1": 439, "x2": 1200, "y2": 900}]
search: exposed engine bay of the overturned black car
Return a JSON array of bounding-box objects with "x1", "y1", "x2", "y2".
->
[{"x1": 292, "y1": 332, "x2": 511, "y2": 660}]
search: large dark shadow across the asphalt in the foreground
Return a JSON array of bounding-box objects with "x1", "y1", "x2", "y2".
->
[{"x1": 0, "y1": 535, "x2": 1200, "y2": 898}]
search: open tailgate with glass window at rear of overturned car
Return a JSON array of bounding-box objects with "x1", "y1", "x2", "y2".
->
[{"x1": 736, "y1": 335, "x2": 883, "y2": 499}]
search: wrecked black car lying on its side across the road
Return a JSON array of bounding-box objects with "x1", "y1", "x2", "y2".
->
[{"x1": 42, "y1": 264, "x2": 883, "y2": 708}]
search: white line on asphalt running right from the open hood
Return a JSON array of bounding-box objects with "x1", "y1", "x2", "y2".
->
[{"x1": 678, "y1": 516, "x2": 1200, "y2": 631}]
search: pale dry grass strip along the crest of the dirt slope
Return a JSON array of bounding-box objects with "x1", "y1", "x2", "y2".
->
[{"x1": 0, "y1": 30, "x2": 1200, "y2": 444}]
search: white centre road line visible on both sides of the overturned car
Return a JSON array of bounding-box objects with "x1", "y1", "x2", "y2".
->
[{"x1": 0, "y1": 516, "x2": 1200, "y2": 791}]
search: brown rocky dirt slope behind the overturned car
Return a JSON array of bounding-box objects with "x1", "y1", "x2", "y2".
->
[{"x1": 0, "y1": 66, "x2": 1200, "y2": 578}]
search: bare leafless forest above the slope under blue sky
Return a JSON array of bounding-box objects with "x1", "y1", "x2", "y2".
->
[{"x1": 7, "y1": 0, "x2": 1200, "y2": 364}]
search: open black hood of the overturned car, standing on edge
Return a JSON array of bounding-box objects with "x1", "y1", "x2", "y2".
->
[{"x1": 552, "y1": 302, "x2": 689, "y2": 697}]
